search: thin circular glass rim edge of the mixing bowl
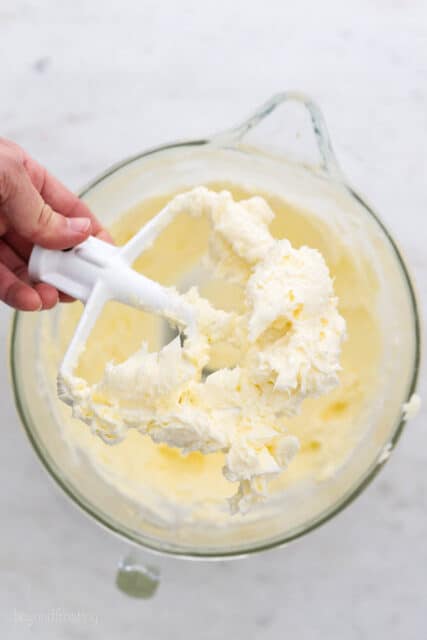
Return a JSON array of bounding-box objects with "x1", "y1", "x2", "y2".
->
[{"x1": 9, "y1": 138, "x2": 421, "y2": 560}]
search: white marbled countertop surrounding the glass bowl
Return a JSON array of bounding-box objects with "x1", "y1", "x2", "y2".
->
[{"x1": 0, "y1": 0, "x2": 427, "y2": 640}]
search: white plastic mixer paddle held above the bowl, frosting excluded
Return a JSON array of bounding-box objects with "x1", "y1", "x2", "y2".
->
[{"x1": 28, "y1": 206, "x2": 196, "y2": 403}]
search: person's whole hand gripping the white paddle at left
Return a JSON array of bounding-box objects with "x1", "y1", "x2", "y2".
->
[{"x1": 0, "y1": 138, "x2": 111, "y2": 311}]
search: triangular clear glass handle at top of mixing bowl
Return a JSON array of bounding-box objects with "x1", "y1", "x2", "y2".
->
[{"x1": 212, "y1": 91, "x2": 343, "y2": 182}]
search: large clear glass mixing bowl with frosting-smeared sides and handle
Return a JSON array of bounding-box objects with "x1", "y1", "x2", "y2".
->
[{"x1": 10, "y1": 93, "x2": 420, "y2": 558}]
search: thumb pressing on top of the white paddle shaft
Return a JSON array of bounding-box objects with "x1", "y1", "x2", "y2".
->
[{"x1": 0, "y1": 158, "x2": 91, "y2": 249}]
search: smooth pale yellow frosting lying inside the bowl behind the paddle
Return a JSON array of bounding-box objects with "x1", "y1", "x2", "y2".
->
[{"x1": 46, "y1": 184, "x2": 383, "y2": 531}]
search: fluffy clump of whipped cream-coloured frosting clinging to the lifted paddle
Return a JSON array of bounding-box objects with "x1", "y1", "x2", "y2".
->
[{"x1": 61, "y1": 187, "x2": 345, "y2": 512}]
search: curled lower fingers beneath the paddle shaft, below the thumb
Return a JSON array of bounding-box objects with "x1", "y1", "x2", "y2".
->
[{"x1": 0, "y1": 240, "x2": 58, "y2": 311}]
